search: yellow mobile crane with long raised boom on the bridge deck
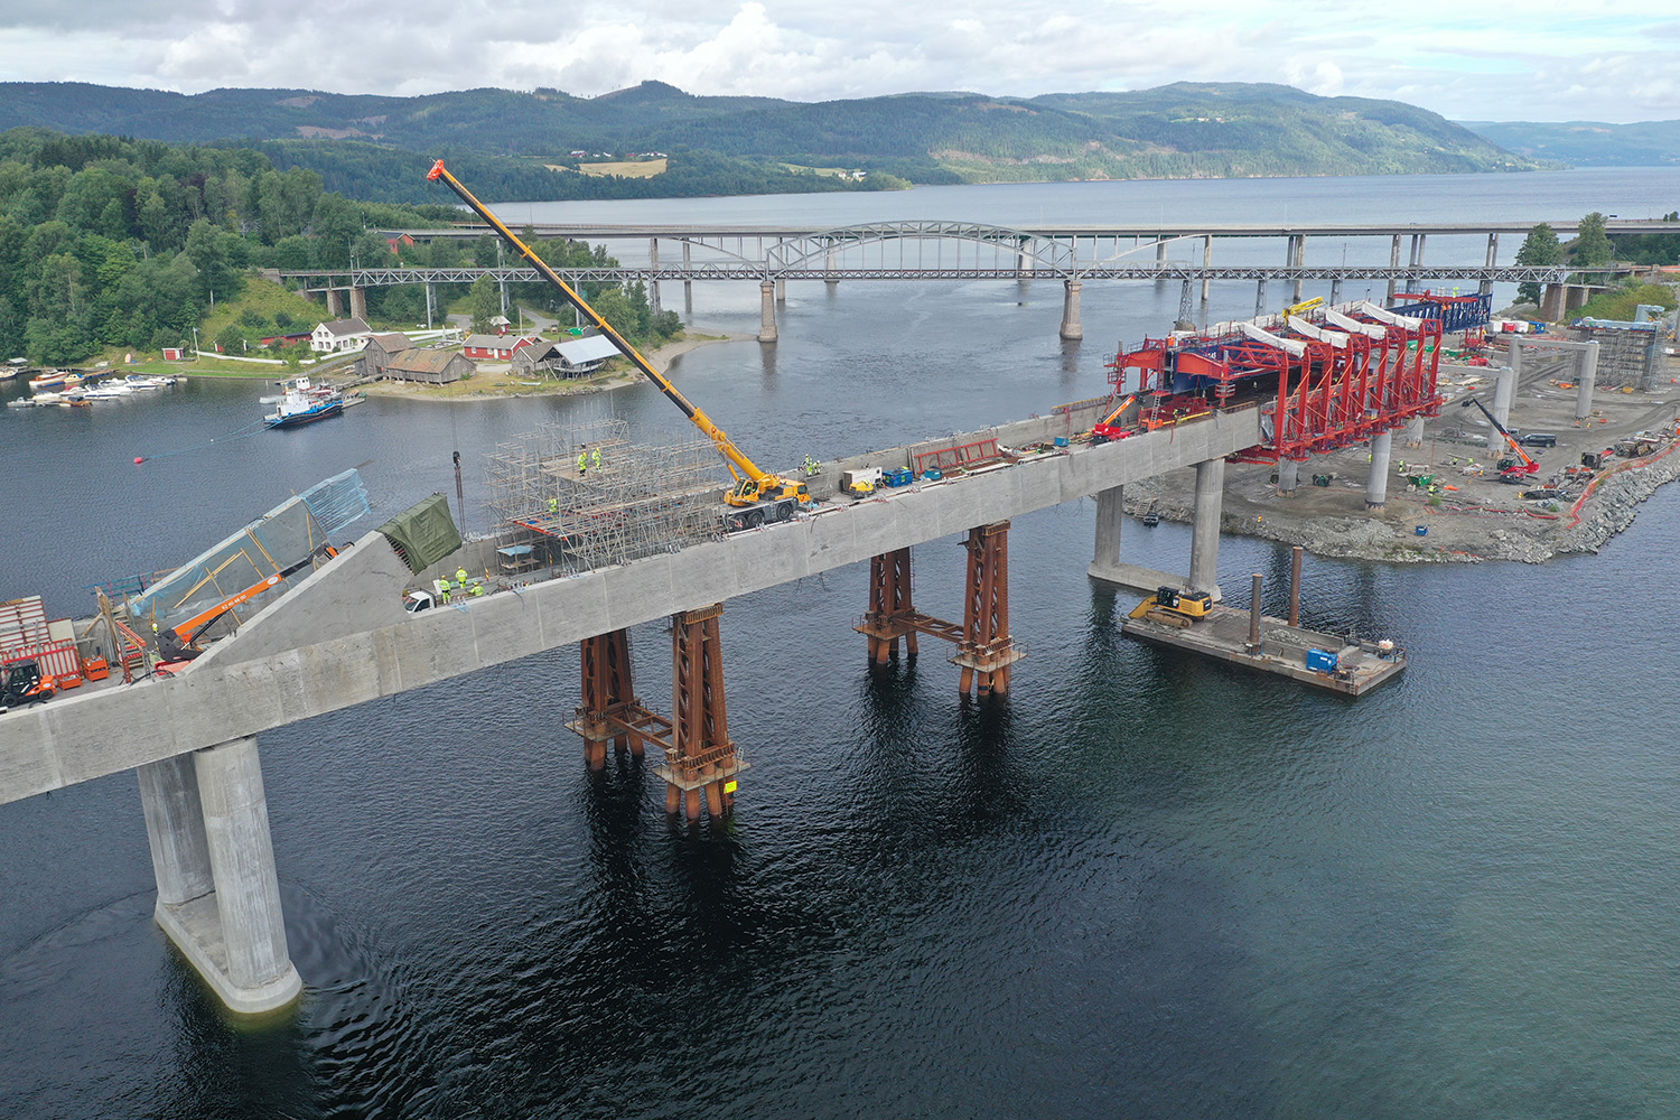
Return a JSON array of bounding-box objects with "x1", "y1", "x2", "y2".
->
[{"x1": 427, "y1": 160, "x2": 811, "y2": 529}]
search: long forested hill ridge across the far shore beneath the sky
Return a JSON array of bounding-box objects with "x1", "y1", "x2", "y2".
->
[{"x1": 0, "y1": 82, "x2": 1534, "y2": 200}]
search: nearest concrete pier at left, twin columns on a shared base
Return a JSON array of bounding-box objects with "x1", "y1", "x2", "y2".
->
[{"x1": 136, "y1": 737, "x2": 302, "y2": 1014}]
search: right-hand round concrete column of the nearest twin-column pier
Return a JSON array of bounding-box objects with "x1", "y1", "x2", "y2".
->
[{"x1": 193, "y1": 737, "x2": 302, "y2": 1011}]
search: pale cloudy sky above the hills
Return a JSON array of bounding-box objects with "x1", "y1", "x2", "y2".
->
[{"x1": 0, "y1": 0, "x2": 1680, "y2": 123}]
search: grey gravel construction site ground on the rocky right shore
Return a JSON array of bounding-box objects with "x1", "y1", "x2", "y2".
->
[{"x1": 1126, "y1": 348, "x2": 1680, "y2": 563}]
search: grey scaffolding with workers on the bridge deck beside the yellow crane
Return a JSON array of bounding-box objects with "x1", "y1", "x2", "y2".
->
[{"x1": 486, "y1": 416, "x2": 724, "y2": 571}]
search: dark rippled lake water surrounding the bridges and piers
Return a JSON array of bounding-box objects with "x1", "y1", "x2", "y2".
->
[{"x1": 0, "y1": 170, "x2": 1680, "y2": 1120}]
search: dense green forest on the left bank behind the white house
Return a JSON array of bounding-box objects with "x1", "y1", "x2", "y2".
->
[{"x1": 0, "y1": 129, "x2": 680, "y2": 364}]
